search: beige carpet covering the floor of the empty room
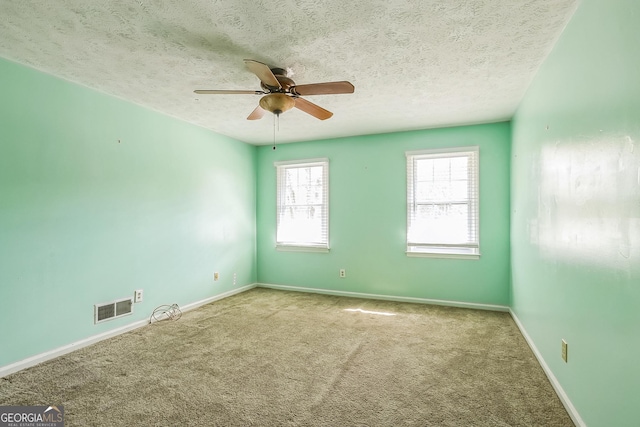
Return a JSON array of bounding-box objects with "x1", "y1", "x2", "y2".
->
[{"x1": 0, "y1": 288, "x2": 573, "y2": 426}]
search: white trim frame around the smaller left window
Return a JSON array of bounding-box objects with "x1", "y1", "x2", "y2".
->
[{"x1": 273, "y1": 157, "x2": 330, "y2": 253}]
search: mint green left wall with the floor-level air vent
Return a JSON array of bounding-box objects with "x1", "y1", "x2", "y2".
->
[{"x1": 0, "y1": 60, "x2": 256, "y2": 366}]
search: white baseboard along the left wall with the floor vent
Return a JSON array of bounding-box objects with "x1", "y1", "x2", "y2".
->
[{"x1": 0, "y1": 283, "x2": 256, "y2": 378}]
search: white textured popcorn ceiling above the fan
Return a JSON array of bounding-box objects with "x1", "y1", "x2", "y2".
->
[{"x1": 0, "y1": 0, "x2": 578, "y2": 144}]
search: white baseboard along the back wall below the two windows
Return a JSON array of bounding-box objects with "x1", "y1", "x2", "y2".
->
[{"x1": 257, "y1": 283, "x2": 509, "y2": 312}]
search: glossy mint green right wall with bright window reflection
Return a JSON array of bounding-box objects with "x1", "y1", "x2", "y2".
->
[{"x1": 511, "y1": 0, "x2": 640, "y2": 426}]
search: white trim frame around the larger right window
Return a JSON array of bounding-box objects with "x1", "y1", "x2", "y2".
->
[{"x1": 405, "y1": 146, "x2": 480, "y2": 259}]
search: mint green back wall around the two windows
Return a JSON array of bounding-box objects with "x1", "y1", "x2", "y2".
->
[{"x1": 257, "y1": 123, "x2": 510, "y2": 305}]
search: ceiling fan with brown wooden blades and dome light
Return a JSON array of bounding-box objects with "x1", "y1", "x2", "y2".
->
[{"x1": 194, "y1": 59, "x2": 355, "y2": 120}]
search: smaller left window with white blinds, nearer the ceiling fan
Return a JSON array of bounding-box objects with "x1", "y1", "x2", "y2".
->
[{"x1": 275, "y1": 159, "x2": 329, "y2": 252}]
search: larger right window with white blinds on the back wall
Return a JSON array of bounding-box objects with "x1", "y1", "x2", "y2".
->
[{"x1": 406, "y1": 147, "x2": 480, "y2": 258}]
